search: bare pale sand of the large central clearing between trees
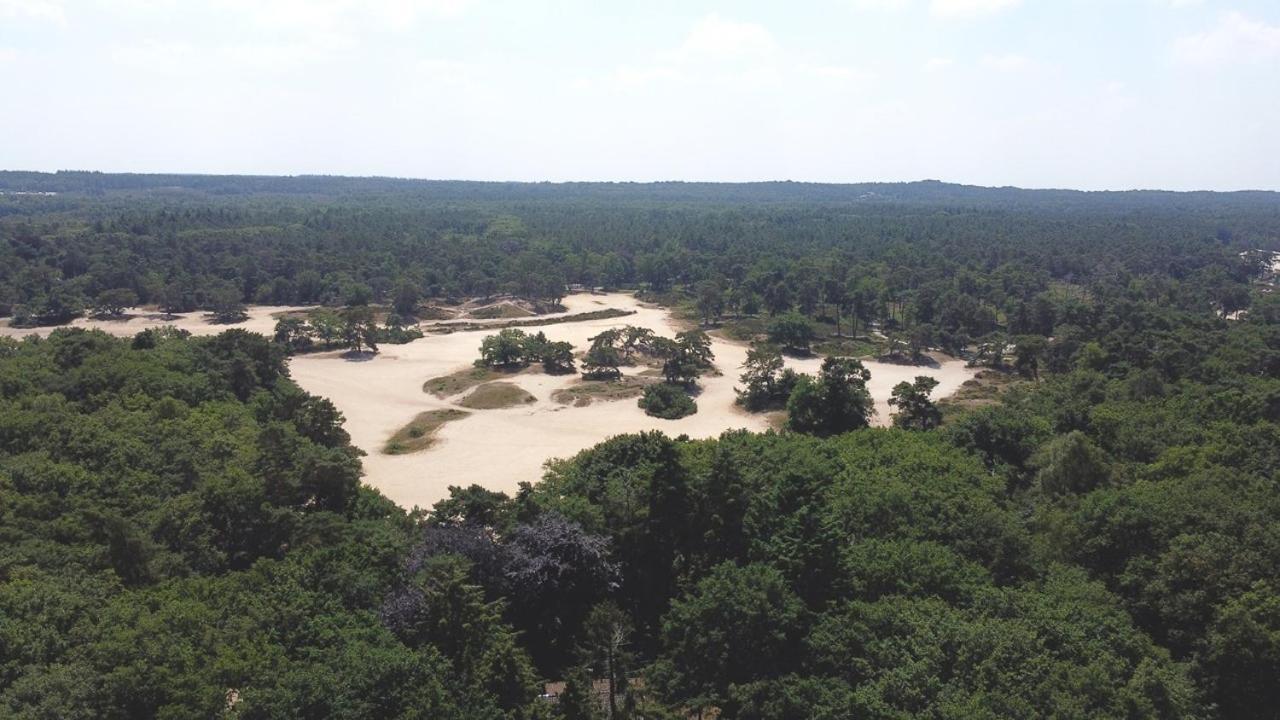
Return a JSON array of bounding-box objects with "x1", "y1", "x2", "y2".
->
[{"x1": 292, "y1": 293, "x2": 974, "y2": 507}]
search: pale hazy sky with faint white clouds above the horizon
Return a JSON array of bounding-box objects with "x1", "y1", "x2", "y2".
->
[{"x1": 0, "y1": 0, "x2": 1280, "y2": 190}]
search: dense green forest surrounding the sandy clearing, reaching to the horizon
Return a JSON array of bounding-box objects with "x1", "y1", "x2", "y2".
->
[{"x1": 0, "y1": 173, "x2": 1280, "y2": 720}]
